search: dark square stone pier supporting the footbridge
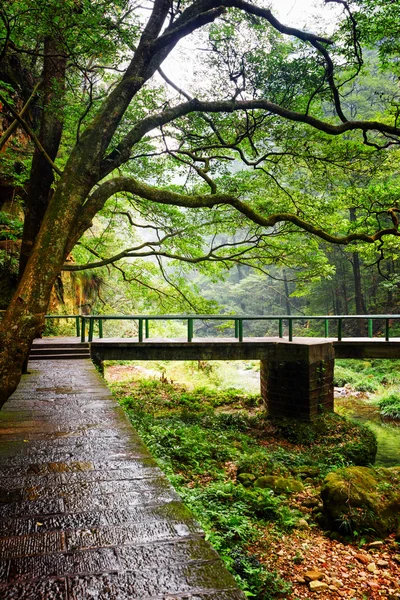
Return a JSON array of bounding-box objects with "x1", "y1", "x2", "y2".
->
[{"x1": 260, "y1": 342, "x2": 335, "y2": 421}]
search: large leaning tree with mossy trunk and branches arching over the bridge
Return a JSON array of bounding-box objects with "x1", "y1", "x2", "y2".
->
[{"x1": 0, "y1": 0, "x2": 400, "y2": 405}]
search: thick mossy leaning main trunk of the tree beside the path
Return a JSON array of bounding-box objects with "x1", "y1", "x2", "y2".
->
[{"x1": 0, "y1": 0, "x2": 171, "y2": 407}]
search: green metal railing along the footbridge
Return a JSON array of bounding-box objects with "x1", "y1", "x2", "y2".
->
[{"x1": 0, "y1": 311, "x2": 400, "y2": 342}]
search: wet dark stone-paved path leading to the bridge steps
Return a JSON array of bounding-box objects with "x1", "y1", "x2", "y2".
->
[{"x1": 0, "y1": 360, "x2": 244, "y2": 600}]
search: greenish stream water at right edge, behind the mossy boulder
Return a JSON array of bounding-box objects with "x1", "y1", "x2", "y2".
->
[{"x1": 335, "y1": 396, "x2": 400, "y2": 467}]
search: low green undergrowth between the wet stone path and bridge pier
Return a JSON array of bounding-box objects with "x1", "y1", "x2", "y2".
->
[{"x1": 110, "y1": 372, "x2": 376, "y2": 600}]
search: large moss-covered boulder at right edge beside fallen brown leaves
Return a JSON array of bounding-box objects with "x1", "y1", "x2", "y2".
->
[{"x1": 321, "y1": 467, "x2": 400, "y2": 535}]
